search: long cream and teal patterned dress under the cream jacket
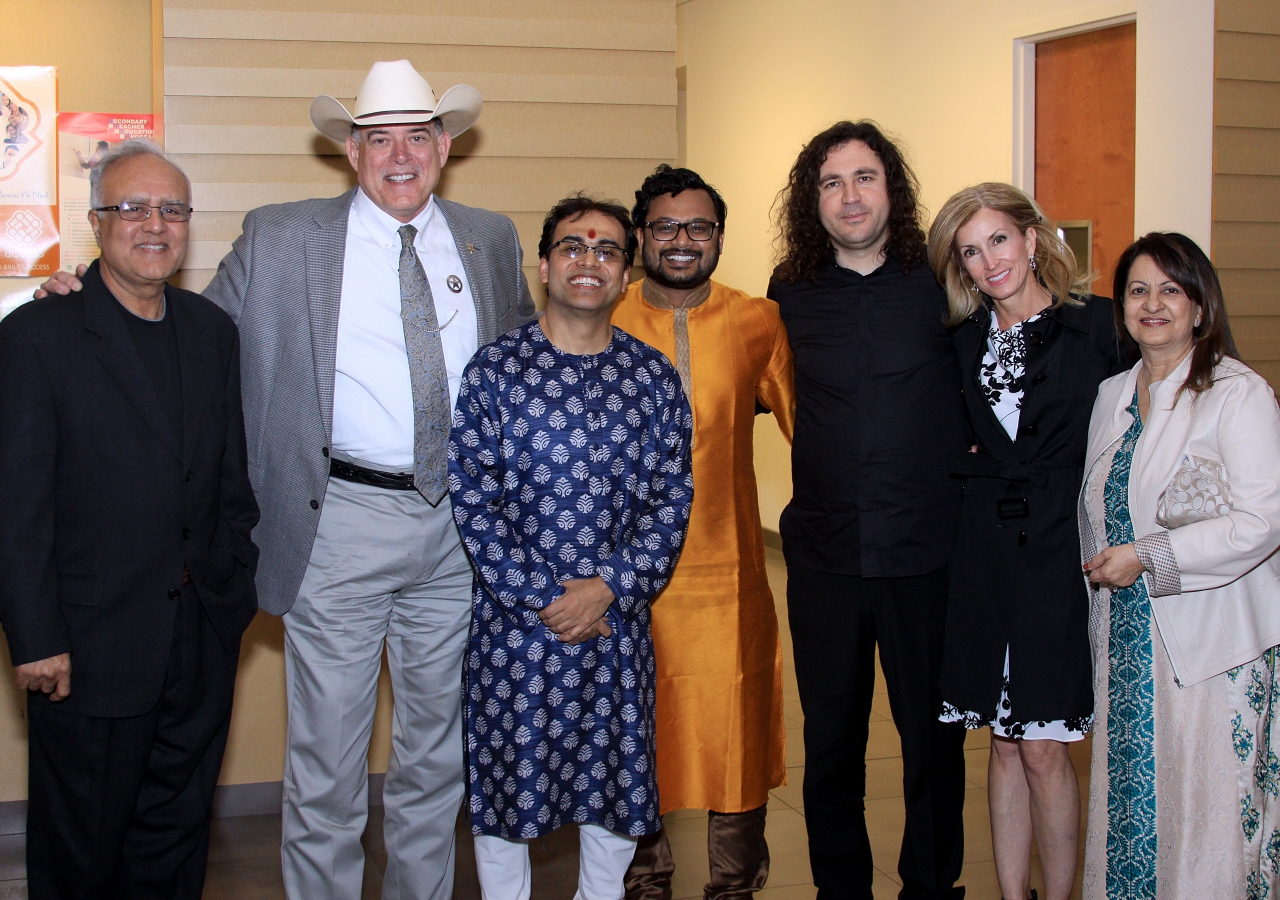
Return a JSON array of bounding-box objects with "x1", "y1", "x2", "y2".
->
[{"x1": 1082, "y1": 394, "x2": 1280, "y2": 900}]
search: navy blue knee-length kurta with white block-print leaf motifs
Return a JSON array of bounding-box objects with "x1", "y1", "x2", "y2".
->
[{"x1": 449, "y1": 321, "x2": 694, "y2": 839}]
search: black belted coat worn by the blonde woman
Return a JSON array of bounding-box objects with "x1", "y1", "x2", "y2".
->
[{"x1": 942, "y1": 297, "x2": 1121, "y2": 722}]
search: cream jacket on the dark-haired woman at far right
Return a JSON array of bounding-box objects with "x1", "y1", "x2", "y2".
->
[{"x1": 1080, "y1": 355, "x2": 1280, "y2": 686}]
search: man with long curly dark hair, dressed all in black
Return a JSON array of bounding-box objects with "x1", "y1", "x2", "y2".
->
[{"x1": 769, "y1": 122, "x2": 966, "y2": 900}]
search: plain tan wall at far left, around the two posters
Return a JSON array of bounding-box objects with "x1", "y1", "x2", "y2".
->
[{"x1": 0, "y1": 0, "x2": 152, "y2": 803}]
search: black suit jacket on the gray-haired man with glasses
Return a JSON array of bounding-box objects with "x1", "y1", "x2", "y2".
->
[{"x1": 0, "y1": 262, "x2": 257, "y2": 717}]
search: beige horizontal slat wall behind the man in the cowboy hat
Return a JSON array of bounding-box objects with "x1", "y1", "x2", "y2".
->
[{"x1": 164, "y1": 0, "x2": 677, "y2": 302}]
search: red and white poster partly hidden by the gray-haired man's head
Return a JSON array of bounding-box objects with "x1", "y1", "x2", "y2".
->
[{"x1": 58, "y1": 113, "x2": 157, "y2": 271}]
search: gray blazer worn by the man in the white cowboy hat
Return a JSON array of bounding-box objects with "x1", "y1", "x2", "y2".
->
[{"x1": 204, "y1": 188, "x2": 534, "y2": 616}]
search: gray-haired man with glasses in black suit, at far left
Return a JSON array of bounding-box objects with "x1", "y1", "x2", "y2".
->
[{"x1": 0, "y1": 141, "x2": 259, "y2": 900}]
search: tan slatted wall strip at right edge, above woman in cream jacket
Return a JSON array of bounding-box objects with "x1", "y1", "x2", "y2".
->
[{"x1": 1212, "y1": 0, "x2": 1280, "y2": 388}]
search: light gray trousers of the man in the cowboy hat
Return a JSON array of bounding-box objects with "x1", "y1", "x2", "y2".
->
[{"x1": 280, "y1": 479, "x2": 471, "y2": 900}]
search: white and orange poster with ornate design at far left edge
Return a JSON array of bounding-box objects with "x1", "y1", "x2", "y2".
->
[{"x1": 0, "y1": 65, "x2": 59, "y2": 277}]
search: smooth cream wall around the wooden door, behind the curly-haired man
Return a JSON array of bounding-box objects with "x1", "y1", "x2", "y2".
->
[{"x1": 677, "y1": 0, "x2": 1213, "y2": 527}]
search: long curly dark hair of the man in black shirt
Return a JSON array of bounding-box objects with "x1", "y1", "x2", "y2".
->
[{"x1": 773, "y1": 119, "x2": 927, "y2": 282}]
